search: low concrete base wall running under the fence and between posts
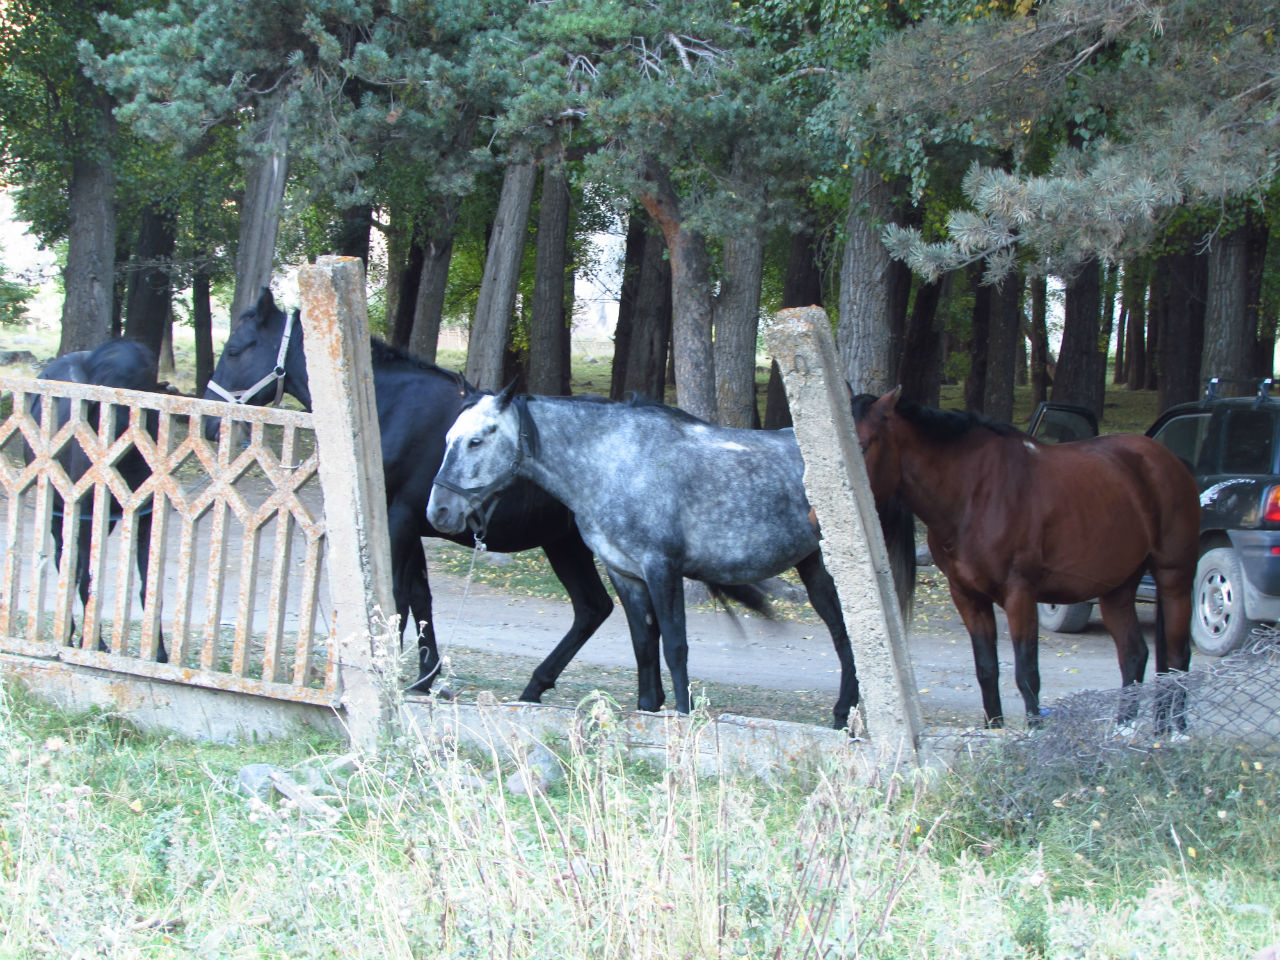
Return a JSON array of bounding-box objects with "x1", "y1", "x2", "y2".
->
[{"x1": 0, "y1": 653, "x2": 980, "y2": 781}]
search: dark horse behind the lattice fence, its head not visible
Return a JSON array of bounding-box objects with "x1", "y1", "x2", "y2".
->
[{"x1": 28, "y1": 339, "x2": 169, "y2": 663}]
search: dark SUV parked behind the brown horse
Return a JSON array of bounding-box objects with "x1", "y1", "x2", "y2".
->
[{"x1": 1032, "y1": 379, "x2": 1280, "y2": 657}]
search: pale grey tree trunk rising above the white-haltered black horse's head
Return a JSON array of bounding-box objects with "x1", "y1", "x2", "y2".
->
[{"x1": 232, "y1": 91, "x2": 289, "y2": 323}]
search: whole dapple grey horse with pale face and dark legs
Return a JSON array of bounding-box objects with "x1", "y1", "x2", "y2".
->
[{"x1": 428, "y1": 389, "x2": 915, "y2": 728}]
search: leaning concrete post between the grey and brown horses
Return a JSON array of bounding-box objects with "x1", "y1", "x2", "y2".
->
[{"x1": 764, "y1": 307, "x2": 924, "y2": 755}]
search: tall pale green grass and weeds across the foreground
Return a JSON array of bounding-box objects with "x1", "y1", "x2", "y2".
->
[{"x1": 0, "y1": 690, "x2": 1280, "y2": 960}]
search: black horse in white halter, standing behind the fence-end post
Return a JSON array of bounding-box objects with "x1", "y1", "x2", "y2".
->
[{"x1": 205, "y1": 289, "x2": 613, "y2": 701}]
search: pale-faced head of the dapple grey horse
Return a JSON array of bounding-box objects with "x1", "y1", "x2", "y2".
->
[{"x1": 426, "y1": 384, "x2": 536, "y2": 539}]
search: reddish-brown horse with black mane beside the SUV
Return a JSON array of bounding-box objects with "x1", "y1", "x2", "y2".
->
[{"x1": 852, "y1": 388, "x2": 1199, "y2": 731}]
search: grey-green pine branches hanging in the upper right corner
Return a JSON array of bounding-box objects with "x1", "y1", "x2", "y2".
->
[{"x1": 845, "y1": 0, "x2": 1280, "y2": 276}]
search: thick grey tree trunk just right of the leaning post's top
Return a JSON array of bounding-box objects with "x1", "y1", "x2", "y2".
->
[{"x1": 836, "y1": 168, "x2": 895, "y2": 394}]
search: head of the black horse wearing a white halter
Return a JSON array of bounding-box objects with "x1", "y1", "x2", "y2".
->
[{"x1": 205, "y1": 287, "x2": 311, "y2": 440}]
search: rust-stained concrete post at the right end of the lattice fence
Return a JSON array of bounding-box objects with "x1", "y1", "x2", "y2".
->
[{"x1": 298, "y1": 256, "x2": 401, "y2": 751}]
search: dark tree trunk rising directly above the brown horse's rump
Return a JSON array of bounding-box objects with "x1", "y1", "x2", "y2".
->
[{"x1": 1151, "y1": 248, "x2": 1208, "y2": 410}]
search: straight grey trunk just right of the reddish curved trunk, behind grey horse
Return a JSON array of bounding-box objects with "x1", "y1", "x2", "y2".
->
[{"x1": 713, "y1": 230, "x2": 764, "y2": 429}]
